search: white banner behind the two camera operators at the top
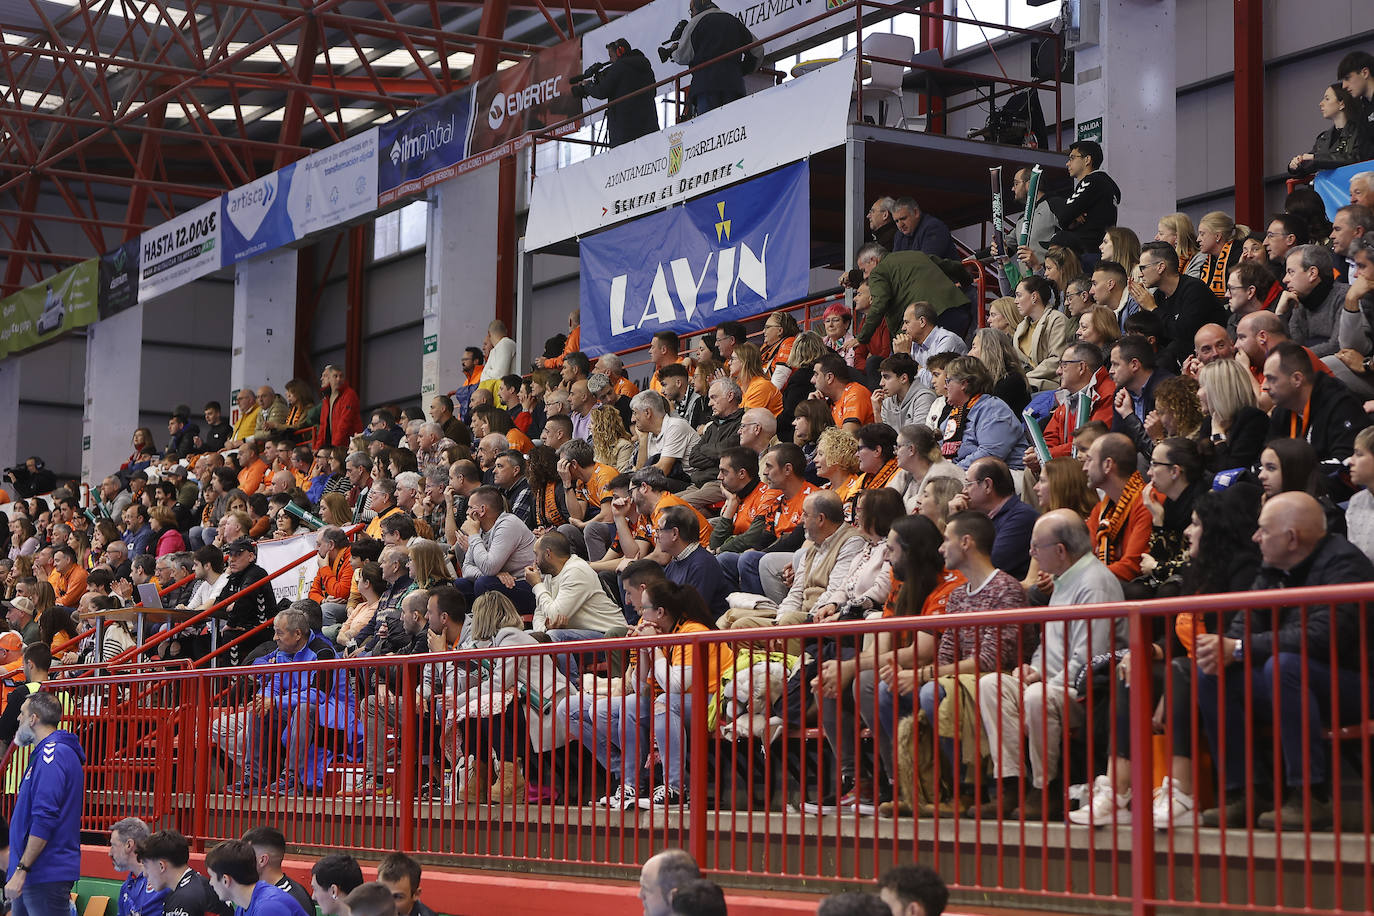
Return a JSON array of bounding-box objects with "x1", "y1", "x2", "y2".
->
[{"x1": 581, "y1": 0, "x2": 846, "y2": 94}]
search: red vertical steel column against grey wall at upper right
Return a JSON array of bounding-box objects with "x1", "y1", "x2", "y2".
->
[{"x1": 1232, "y1": 0, "x2": 1264, "y2": 225}]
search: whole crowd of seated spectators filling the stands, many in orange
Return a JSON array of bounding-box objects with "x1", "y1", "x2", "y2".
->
[{"x1": 0, "y1": 52, "x2": 1374, "y2": 845}]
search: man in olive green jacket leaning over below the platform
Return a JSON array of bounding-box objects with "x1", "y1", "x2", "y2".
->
[{"x1": 841, "y1": 243, "x2": 971, "y2": 346}]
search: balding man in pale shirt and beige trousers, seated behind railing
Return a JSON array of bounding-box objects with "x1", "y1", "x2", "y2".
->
[{"x1": 978, "y1": 513, "x2": 1134, "y2": 820}]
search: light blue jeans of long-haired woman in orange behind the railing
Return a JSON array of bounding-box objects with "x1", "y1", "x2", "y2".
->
[{"x1": 572, "y1": 694, "x2": 691, "y2": 792}]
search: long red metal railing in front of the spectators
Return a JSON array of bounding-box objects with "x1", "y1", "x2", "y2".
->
[{"x1": 26, "y1": 584, "x2": 1374, "y2": 913}]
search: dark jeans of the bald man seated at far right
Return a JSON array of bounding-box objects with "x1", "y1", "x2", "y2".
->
[{"x1": 1198, "y1": 652, "x2": 1360, "y2": 792}]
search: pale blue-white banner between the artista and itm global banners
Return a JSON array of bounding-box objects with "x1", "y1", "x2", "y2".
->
[{"x1": 284, "y1": 128, "x2": 378, "y2": 239}]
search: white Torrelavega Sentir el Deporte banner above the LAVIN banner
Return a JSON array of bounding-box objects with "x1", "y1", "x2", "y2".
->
[{"x1": 525, "y1": 59, "x2": 855, "y2": 251}]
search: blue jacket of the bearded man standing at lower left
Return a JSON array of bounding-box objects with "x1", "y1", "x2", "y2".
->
[{"x1": 5, "y1": 729, "x2": 85, "y2": 884}]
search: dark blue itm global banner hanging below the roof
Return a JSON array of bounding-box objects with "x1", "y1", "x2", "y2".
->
[{"x1": 376, "y1": 89, "x2": 473, "y2": 206}]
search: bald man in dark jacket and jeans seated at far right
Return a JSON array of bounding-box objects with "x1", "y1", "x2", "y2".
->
[{"x1": 1195, "y1": 492, "x2": 1374, "y2": 831}]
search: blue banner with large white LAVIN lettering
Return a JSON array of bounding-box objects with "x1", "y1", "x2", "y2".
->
[{"x1": 580, "y1": 162, "x2": 811, "y2": 356}]
